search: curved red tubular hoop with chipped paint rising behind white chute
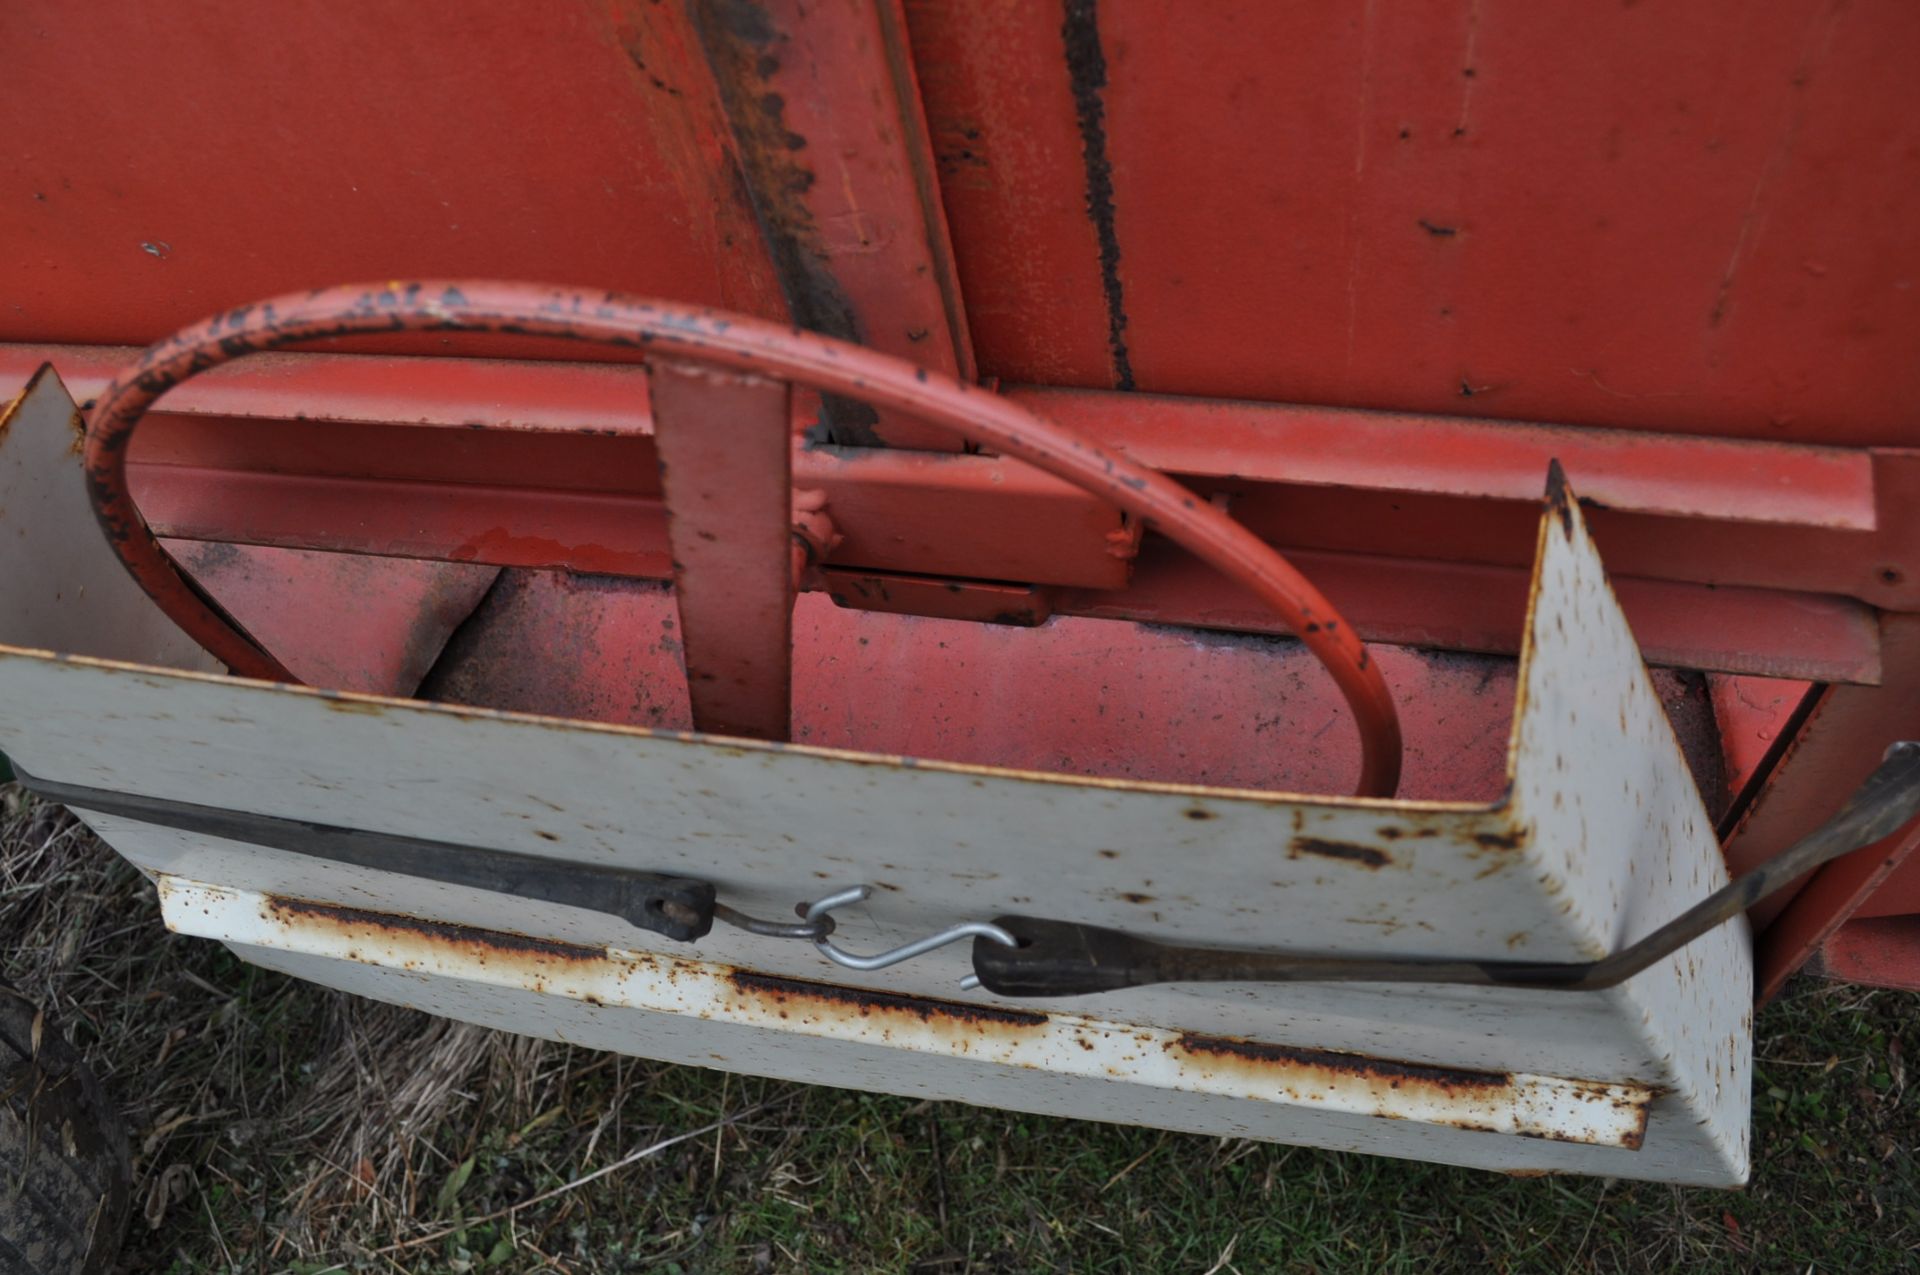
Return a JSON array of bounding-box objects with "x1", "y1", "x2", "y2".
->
[{"x1": 84, "y1": 282, "x2": 1400, "y2": 795}]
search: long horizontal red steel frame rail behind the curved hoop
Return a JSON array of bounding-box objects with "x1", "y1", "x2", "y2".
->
[{"x1": 0, "y1": 346, "x2": 1889, "y2": 684}]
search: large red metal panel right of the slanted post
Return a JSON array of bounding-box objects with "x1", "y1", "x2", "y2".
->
[{"x1": 910, "y1": 0, "x2": 1920, "y2": 445}]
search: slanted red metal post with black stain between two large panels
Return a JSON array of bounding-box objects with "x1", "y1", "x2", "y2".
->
[{"x1": 687, "y1": 0, "x2": 973, "y2": 451}]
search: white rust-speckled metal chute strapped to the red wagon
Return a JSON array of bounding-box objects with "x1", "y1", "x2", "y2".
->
[{"x1": 0, "y1": 368, "x2": 1751, "y2": 1185}]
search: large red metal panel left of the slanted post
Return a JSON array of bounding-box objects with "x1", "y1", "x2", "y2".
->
[{"x1": 0, "y1": 0, "x2": 787, "y2": 359}]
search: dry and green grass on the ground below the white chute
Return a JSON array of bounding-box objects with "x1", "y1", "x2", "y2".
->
[{"x1": 0, "y1": 793, "x2": 1920, "y2": 1275}]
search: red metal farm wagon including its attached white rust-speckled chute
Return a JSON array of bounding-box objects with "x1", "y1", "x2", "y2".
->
[{"x1": 0, "y1": 0, "x2": 1920, "y2": 1183}]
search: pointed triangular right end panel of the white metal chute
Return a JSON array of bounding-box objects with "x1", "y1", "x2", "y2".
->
[{"x1": 1507, "y1": 467, "x2": 1753, "y2": 1181}]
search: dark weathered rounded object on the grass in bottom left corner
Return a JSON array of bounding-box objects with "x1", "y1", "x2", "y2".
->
[{"x1": 0, "y1": 983, "x2": 132, "y2": 1275}]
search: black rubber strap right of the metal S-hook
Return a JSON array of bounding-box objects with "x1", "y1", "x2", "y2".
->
[{"x1": 973, "y1": 741, "x2": 1920, "y2": 997}]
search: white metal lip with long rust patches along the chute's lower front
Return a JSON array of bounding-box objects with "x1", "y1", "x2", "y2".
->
[{"x1": 156, "y1": 876, "x2": 1655, "y2": 1150}]
